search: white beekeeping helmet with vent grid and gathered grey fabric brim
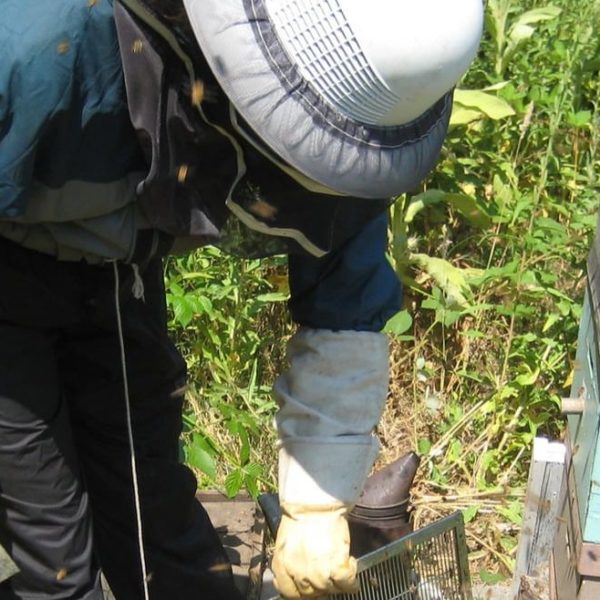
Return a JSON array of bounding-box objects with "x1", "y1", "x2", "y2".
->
[{"x1": 184, "y1": 0, "x2": 483, "y2": 198}]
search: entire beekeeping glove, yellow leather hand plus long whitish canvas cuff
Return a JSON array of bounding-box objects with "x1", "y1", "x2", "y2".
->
[{"x1": 271, "y1": 328, "x2": 388, "y2": 599}]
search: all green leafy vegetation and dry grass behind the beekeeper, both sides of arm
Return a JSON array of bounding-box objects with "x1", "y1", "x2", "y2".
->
[{"x1": 166, "y1": 0, "x2": 600, "y2": 580}]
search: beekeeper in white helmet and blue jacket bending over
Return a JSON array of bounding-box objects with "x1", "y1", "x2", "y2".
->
[{"x1": 0, "y1": 0, "x2": 482, "y2": 600}]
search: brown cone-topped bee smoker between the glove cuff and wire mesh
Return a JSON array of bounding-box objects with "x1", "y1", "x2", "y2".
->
[{"x1": 348, "y1": 452, "x2": 421, "y2": 558}]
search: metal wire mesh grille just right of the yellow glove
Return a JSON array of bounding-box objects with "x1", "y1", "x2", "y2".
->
[{"x1": 329, "y1": 512, "x2": 472, "y2": 600}]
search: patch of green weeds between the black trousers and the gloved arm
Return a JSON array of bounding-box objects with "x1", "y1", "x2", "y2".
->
[{"x1": 166, "y1": 248, "x2": 291, "y2": 496}]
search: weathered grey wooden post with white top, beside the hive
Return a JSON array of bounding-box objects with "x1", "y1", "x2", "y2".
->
[{"x1": 511, "y1": 438, "x2": 566, "y2": 598}]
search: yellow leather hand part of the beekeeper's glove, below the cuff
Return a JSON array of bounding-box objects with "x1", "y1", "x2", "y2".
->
[{"x1": 271, "y1": 504, "x2": 358, "y2": 600}]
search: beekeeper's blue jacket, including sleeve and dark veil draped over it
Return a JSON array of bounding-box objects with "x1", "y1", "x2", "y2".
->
[{"x1": 0, "y1": 0, "x2": 400, "y2": 331}]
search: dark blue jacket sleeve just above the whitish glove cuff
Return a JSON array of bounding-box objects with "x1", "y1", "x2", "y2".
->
[{"x1": 289, "y1": 212, "x2": 402, "y2": 331}]
